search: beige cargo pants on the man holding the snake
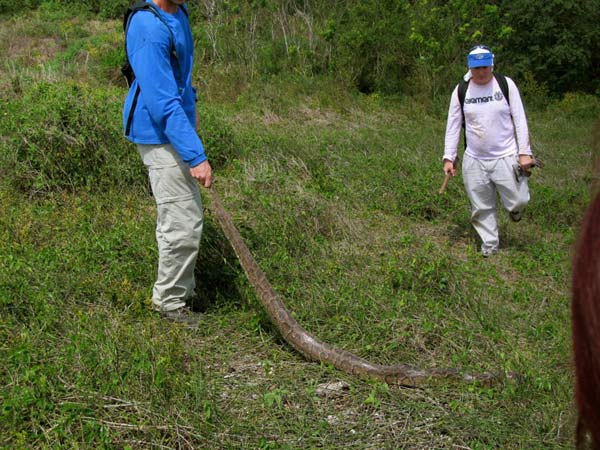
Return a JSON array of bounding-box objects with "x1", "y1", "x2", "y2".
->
[{"x1": 138, "y1": 144, "x2": 203, "y2": 311}]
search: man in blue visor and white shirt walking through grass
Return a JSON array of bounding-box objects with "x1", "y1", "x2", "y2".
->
[{"x1": 443, "y1": 45, "x2": 534, "y2": 257}]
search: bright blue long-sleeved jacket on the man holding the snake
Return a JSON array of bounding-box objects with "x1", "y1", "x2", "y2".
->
[{"x1": 123, "y1": 0, "x2": 206, "y2": 167}]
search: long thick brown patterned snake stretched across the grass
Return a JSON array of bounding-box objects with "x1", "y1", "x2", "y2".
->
[{"x1": 211, "y1": 186, "x2": 498, "y2": 387}]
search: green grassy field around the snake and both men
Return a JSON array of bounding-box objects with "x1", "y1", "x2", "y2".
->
[{"x1": 0, "y1": 7, "x2": 600, "y2": 450}]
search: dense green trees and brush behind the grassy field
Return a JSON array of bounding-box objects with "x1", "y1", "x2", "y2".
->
[{"x1": 0, "y1": 0, "x2": 600, "y2": 96}]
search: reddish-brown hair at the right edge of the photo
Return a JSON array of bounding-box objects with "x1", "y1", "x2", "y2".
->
[{"x1": 571, "y1": 189, "x2": 600, "y2": 450}]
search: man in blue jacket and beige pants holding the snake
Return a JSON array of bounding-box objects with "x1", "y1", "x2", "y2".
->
[{"x1": 123, "y1": 0, "x2": 212, "y2": 323}]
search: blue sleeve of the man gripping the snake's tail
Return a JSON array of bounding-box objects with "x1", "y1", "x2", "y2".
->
[{"x1": 127, "y1": 14, "x2": 206, "y2": 167}]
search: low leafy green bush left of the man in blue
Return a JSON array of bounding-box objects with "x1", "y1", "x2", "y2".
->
[{"x1": 0, "y1": 82, "x2": 146, "y2": 193}]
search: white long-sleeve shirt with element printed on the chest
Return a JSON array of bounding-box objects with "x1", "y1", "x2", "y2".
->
[{"x1": 444, "y1": 77, "x2": 532, "y2": 161}]
